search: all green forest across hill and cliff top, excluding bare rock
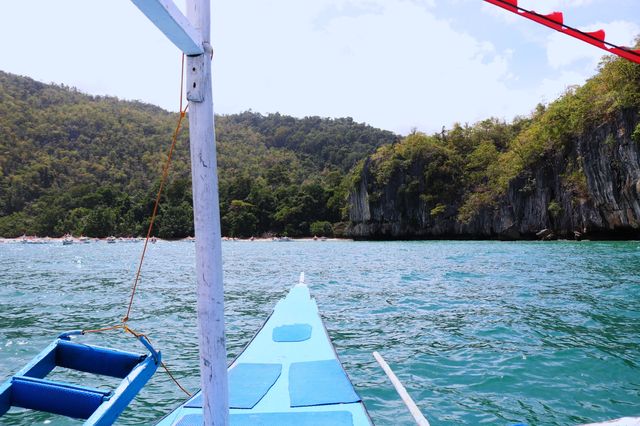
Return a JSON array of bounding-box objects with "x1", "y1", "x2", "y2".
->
[{"x1": 0, "y1": 47, "x2": 640, "y2": 238}]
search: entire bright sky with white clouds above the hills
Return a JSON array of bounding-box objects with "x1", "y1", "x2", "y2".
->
[{"x1": 0, "y1": 0, "x2": 640, "y2": 134}]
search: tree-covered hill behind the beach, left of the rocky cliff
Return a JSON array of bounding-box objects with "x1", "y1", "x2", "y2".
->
[{"x1": 0, "y1": 72, "x2": 399, "y2": 238}]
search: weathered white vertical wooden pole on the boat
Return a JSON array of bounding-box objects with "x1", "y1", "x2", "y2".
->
[{"x1": 187, "y1": 0, "x2": 229, "y2": 426}]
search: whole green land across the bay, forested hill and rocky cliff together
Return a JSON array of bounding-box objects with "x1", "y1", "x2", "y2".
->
[{"x1": 0, "y1": 46, "x2": 640, "y2": 238}]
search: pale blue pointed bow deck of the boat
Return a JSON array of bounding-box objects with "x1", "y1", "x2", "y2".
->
[{"x1": 159, "y1": 283, "x2": 372, "y2": 426}]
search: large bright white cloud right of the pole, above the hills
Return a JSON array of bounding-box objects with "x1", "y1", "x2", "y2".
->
[{"x1": 210, "y1": 1, "x2": 524, "y2": 132}]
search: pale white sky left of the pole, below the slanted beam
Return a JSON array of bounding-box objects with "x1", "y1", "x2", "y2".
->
[{"x1": 0, "y1": 0, "x2": 186, "y2": 109}]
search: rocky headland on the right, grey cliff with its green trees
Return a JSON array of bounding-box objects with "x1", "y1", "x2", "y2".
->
[{"x1": 347, "y1": 51, "x2": 640, "y2": 239}]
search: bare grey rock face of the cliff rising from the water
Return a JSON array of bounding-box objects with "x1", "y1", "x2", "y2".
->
[{"x1": 346, "y1": 109, "x2": 640, "y2": 239}]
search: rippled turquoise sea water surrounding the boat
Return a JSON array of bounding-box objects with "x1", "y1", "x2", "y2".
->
[{"x1": 0, "y1": 241, "x2": 640, "y2": 425}]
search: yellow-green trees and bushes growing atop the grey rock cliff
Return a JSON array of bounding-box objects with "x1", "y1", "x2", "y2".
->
[{"x1": 351, "y1": 50, "x2": 640, "y2": 222}]
